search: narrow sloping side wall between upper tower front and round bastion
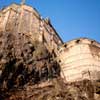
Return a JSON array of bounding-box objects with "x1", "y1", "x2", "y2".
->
[{"x1": 42, "y1": 20, "x2": 63, "y2": 54}]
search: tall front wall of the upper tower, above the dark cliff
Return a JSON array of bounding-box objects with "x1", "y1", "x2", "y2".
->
[{"x1": 0, "y1": 4, "x2": 40, "y2": 37}]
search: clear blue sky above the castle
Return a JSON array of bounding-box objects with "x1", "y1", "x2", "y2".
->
[{"x1": 0, "y1": 0, "x2": 100, "y2": 42}]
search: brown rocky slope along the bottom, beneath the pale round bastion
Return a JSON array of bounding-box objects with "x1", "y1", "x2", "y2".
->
[{"x1": 2, "y1": 78, "x2": 100, "y2": 100}]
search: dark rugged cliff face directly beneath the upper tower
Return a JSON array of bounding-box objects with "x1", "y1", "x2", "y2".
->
[{"x1": 0, "y1": 30, "x2": 59, "y2": 89}]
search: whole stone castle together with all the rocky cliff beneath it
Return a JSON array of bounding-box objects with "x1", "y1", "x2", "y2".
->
[{"x1": 0, "y1": 4, "x2": 100, "y2": 100}]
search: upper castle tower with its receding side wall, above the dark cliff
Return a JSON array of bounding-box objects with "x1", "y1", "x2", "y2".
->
[{"x1": 0, "y1": 4, "x2": 63, "y2": 53}]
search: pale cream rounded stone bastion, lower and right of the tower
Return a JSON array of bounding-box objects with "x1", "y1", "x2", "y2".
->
[{"x1": 57, "y1": 38, "x2": 100, "y2": 82}]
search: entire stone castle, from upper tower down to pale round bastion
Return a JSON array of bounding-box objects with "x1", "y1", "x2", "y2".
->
[{"x1": 0, "y1": 4, "x2": 100, "y2": 82}]
